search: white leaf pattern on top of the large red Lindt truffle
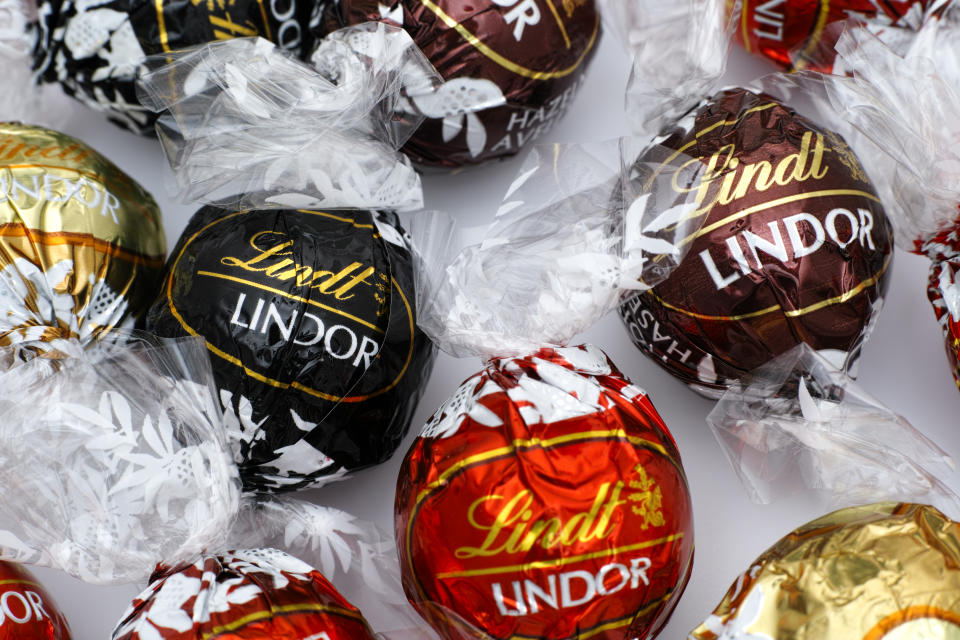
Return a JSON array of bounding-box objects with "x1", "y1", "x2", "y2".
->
[{"x1": 420, "y1": 345, "x2": 644, "y2": 438}]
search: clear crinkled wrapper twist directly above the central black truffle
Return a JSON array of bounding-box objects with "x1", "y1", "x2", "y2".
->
[{"x1": 138, "y1": 23, "x2": 439, "y2": 209}]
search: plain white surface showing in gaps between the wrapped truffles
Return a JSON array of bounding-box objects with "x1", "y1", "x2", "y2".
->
[{"x1": 20, "y1": 27, "x2": 960, "y2": 640}]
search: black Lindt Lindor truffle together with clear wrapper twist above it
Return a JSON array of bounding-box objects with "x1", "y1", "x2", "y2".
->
[{"x1": 139, "y1": 23, "x2": 442, "y2": 492}]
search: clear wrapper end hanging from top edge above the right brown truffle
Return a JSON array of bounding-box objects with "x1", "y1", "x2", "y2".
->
[{"x1": 607, "y1": 0, "x2": 740, "y2": 134}]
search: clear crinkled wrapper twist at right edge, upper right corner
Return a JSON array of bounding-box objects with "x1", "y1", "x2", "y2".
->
[{"x1": 824, "y1": 20, "x2": 960, "y2": 251}]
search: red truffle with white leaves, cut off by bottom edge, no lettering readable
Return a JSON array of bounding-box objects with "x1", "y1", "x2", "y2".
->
[{"x1": 111, "y1": 549, "x2": 374, "y2": 640}]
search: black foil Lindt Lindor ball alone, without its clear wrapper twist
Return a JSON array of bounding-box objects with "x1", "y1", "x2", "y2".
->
[{"x1": 147, "y1": 207, "x2": 433, "y2": 491}]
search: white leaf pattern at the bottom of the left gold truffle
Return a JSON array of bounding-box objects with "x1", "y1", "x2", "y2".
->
[{"x1": 0, "y1": 258, "x2": 133, "y2": 350}]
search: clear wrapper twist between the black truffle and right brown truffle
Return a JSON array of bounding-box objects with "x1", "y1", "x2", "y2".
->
[{"x1": 418, "y1": 140, "x2": 703, "y2": 358}]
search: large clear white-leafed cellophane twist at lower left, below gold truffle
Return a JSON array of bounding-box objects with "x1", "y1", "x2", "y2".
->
[{"x1": 0, "y1": 333, "x2": 442, "y2": 640}]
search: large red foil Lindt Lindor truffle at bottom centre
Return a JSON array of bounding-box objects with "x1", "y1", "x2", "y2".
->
[{"x1": 395, "y1": 346, "x2": 693, "y2": 640}]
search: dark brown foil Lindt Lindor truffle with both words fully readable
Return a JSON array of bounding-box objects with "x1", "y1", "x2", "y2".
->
[{"x1": 620, "y1": 89, "x2": 893, "y2": 395}]
